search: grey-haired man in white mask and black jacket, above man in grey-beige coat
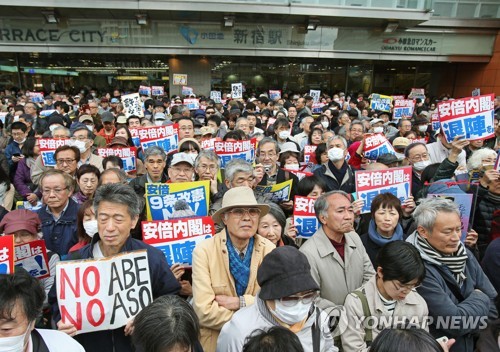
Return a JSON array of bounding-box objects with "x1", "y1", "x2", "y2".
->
[{"x1": 314, "y1": 136, "x2": 356, "y2": 193}]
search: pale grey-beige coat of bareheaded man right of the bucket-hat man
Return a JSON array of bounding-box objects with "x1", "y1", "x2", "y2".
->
[{"x1": 300, "y1": 227, "x2": 375, "y2": 307}]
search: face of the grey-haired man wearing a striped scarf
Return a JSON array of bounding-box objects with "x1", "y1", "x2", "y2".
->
[{"x1": 417, "y1": 212, "x2": 462, "y2": 255}]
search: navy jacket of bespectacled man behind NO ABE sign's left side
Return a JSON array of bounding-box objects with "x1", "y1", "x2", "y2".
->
[{"x1": 37, "y1": 199, "x2": 80, "y2": 257}]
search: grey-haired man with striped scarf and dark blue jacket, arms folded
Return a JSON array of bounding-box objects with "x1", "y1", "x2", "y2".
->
[{"x1": 407, "y1": 198, "x2": 498, "y2": 352}]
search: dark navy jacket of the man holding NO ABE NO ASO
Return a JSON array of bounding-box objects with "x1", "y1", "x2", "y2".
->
[{"x1": 49, "y1": 234, "x2": 181, "y2": 352}]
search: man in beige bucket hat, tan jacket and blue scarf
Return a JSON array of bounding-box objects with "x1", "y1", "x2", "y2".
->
[{"x1": 193, "y1": 187, "x2": 275, "y2": 352}]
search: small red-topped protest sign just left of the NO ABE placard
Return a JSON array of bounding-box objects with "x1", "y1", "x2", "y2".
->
[{"x1": 14, "y1": 240, "x2": 50, "y2": 279}]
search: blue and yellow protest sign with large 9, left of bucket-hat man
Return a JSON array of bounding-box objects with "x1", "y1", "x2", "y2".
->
[{"x1": 145, "y1": 181, "x2": 210, "y2": 220}]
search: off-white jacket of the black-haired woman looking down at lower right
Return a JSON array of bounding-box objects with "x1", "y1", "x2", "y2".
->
[{"x1": 341, "y1": 275, "x2": 429, "y2": 352}]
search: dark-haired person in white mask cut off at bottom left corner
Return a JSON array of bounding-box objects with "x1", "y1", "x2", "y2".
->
[{"x1": 0, "y1": 269, "x2": 85, "y2": 352}]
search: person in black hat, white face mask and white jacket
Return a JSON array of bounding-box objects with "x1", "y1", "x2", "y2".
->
[{"x1": 217, "y1": 246, "x2": 338, "y2": 352}]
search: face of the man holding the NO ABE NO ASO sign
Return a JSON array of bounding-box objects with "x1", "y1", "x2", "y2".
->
[{"x1": 97, "y1": 201, "x2": 139, "y2": 253}]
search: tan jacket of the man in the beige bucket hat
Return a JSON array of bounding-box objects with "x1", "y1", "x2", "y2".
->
[{"x1": 193, "y1": 230, "x2": 276, "y2": 352}]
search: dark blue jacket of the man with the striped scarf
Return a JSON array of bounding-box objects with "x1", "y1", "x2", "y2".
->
[{"x1": 407, "y1": 233, "x2": 498, "y2": 352}]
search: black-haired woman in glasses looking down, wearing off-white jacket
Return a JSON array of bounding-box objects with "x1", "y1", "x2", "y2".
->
[{"x1": 341, "y1": 241, "x2": 428, "y2": 352}]
